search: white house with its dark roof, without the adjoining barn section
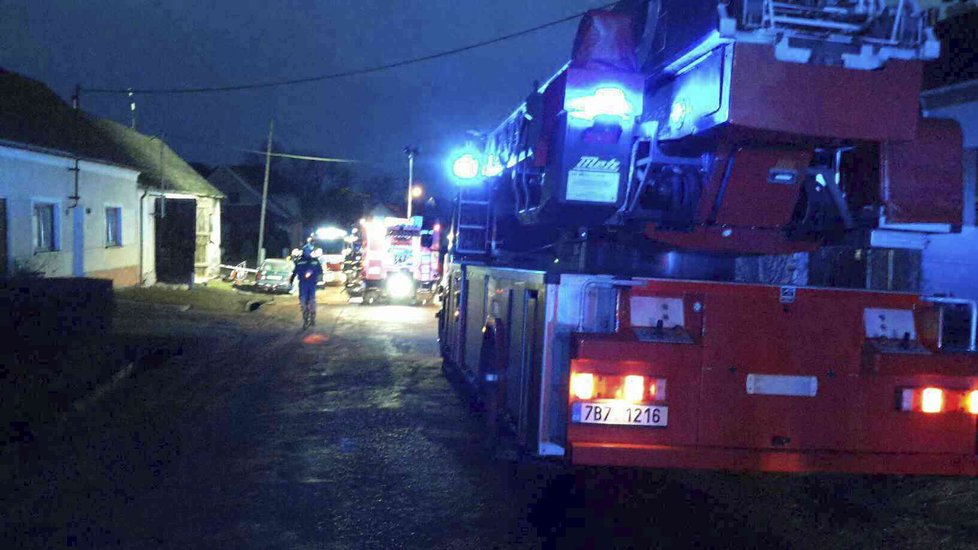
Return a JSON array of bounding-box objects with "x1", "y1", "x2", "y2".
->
[{"x1": 0, "y1": 72, "x2": 141, "y2": 286}]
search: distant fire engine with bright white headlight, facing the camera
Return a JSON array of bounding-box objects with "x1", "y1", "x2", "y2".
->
[{"x1": 346, "y1": 216, "x2": 441, "y2": 305}]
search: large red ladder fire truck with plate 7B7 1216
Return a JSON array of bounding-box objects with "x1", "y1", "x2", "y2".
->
[{"x1": 440, "y1": 0, "x2": 978, "y2": 475}]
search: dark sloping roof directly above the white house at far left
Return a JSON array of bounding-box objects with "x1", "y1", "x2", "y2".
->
[{"x1": 0, "y1": 69, "x2": 134, "y2": 167}]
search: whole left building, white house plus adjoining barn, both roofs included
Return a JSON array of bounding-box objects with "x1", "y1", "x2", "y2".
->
[{"x1": 0, "y1": 69, "x2": 223, "y2": 286}]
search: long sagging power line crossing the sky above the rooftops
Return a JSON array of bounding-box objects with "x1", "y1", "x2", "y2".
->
[{"x1": 83, "y1": 2, "x2": 618, "y2": 95}]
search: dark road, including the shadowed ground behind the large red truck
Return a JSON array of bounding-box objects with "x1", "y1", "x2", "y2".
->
[{"x1": 2, "y1": 290, "x2": 978, "y2": 548}]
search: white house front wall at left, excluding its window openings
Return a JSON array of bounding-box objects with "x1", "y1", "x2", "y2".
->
[{"x1": 0, "y1": 146, "x2": 139, "y2": 277}]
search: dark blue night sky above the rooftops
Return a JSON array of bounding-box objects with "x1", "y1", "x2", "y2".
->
[{"x1": 0, "y1": 0, "x2": 607, "y2": 203}]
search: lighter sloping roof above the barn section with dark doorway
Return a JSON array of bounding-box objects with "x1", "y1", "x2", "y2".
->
[{"x1": 95, "y1": 119, "x2": 224, "y2": 198}]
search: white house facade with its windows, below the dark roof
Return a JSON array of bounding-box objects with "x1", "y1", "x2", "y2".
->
[{"x1": 0, "y1": 142, "x2": 140, "y2": 286}]
